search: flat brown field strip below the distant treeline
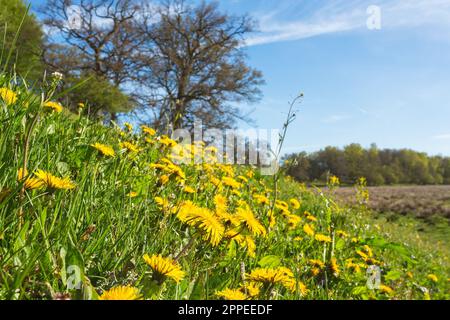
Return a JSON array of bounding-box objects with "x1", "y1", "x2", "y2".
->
[{"x1": 334, "y1": 186, "x2": 450, "y2": 219}]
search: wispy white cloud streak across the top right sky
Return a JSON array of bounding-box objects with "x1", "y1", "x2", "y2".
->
[{"x1": 246, "y1": 0, "x2": 450, "y2": 46}]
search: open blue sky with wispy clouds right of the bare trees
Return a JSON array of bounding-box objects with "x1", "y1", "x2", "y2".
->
[{"x1": 31, "y1": 0, "x2": 450, "y2": 155}]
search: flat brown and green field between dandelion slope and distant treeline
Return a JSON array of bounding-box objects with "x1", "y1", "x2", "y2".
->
[{"x1": 326, "y1": 186, "x2": 450, "y2": 274}]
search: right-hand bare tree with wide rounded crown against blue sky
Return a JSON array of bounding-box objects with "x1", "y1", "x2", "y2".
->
[{"x1": 141, "y1": 1, "x2": 263, "y2": 129}]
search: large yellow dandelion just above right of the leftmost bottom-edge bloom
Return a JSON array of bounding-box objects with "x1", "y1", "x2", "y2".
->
[{"x1": 144, "y1": 254, "x2": 185, "y2": 284}]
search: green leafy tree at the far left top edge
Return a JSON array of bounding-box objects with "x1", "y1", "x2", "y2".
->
[{"x1": 0, "y1": 0, "x2": 43, "y2": 80}]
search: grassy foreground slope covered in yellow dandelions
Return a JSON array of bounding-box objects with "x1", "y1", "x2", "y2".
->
[{"x1": 0, "y1": 74, "x2": 450, "y2": 300}]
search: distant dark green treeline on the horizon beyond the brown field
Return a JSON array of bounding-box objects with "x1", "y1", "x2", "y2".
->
[{"x1": 284, "y1": 144, "x2": 450, "y2": 185}]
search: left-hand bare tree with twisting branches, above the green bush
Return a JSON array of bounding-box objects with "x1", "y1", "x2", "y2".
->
[{"x1": 41, "y1": 0, "x2": 150, "y2": 118}]
